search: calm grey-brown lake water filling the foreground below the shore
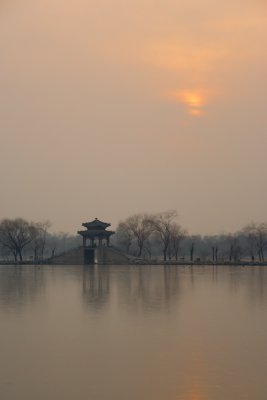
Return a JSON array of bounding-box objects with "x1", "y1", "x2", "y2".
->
[{"x1": 0, "y1": 266, "x2": 267, "y2": 400}]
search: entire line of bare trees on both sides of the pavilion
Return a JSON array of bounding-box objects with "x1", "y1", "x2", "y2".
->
[{"x1": 0, "y1": 214, "x2": 267, "y2": 263}]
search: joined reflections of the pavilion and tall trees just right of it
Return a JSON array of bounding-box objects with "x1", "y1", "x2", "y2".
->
[{"x1": 82, "y1": 266, "x2": 180, "y2": 312}]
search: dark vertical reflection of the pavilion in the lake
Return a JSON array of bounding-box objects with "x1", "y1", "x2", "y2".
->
[{"x1": 83, "y1": 266, "x2": 109, "y2": 307}]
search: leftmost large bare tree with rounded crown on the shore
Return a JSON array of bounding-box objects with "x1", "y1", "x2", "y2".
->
[{"x1": 0, "y1": 218, "x2": 38, "y2": 262}]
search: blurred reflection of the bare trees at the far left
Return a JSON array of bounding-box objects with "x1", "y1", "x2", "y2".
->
[{"x1": 0, "y1": 266, "x2": 45, "y2": 308}]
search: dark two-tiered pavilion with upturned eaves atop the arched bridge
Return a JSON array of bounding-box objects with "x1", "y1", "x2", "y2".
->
[{"x1": 78, "y1": 218, "x2": 115, "y2": 248}]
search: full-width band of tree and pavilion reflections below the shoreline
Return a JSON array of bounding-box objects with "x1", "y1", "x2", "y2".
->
[{"x1": 0, "y1": 266, "x2": 267, "y2": 312}]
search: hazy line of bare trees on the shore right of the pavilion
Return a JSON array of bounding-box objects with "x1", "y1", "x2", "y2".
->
[{"x1": 114, "y1": 210, "x2": 267, "y2": 263}]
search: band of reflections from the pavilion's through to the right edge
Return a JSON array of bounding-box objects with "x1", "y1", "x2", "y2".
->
[{"x1": 82, "y1": 266, "x2": 267, "y2": 312}]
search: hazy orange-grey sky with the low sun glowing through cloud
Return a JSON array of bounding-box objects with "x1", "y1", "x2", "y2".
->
[{"x1": 0, "y1": 0, "x2": 267, "y2": 233}]
